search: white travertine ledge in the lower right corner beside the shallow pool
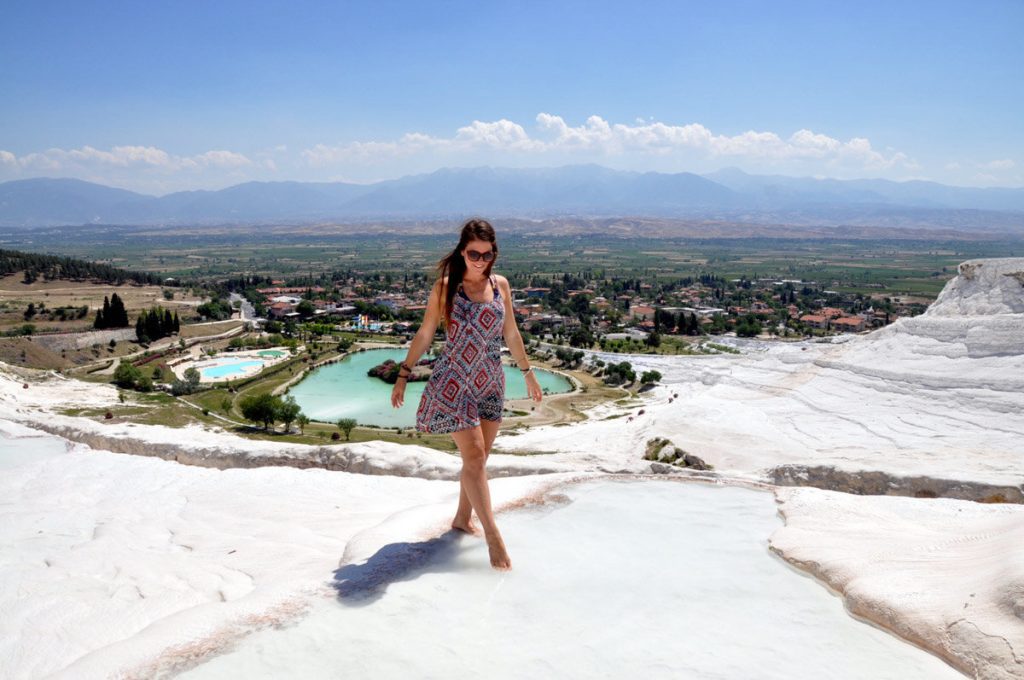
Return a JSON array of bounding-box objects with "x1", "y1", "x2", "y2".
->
[{"x1": 770, "y1": 488, "x2": 1024, "y2": 680}]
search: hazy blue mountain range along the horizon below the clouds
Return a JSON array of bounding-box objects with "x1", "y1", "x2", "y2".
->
[{"x1": 0, "y1": 165, "x2": 1024, "y2": 230}]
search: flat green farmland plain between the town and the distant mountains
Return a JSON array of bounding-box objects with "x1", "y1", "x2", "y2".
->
[{"x1": 0, "y1": 226, "x2": 1024, "y2": 299}]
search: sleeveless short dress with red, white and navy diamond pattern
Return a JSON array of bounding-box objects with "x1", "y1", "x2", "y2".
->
[{"x1": 416, "y1": 275, "x2": 505, "y2": 433}]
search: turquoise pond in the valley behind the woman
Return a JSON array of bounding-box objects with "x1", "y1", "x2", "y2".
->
[{"x1": 288, "y1": 349, "x2": 572, "y2": 427}]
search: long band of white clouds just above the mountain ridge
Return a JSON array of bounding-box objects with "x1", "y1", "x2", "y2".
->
[{"x1": 0, "y1": 112, "x2": 1007, "y2": 192}]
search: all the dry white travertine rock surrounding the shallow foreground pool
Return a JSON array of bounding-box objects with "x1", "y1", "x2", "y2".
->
[{"x1": 0, "y1": 258, "x2": 1024, "y2": 679}]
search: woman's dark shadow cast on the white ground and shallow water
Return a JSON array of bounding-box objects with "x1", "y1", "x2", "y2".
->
[{"x1": 331, "y1": 529, "x2": 471, "y2": 606}]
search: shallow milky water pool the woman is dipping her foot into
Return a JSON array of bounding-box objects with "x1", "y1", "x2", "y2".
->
[{"x1": 180, "y1": 480, "x2": 963, "y2": 680}]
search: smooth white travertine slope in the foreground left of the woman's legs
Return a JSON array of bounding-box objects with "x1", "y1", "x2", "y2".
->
[{"x1": 0, "y1": 428, "x2": 585, "y2": 680}]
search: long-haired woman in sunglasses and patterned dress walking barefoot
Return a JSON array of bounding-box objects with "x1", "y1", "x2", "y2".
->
[{"x1": 391, "y1": 219, "x2": 542, "y2": 569}]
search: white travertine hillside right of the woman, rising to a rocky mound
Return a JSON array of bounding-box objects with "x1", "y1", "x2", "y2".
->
[{"x1": 496, "y1": 259, "x2": 1024, "y2": 486}]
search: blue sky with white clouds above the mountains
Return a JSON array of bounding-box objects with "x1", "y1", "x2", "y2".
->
[{"x1": 0, "y1": 0, "x2": 1024, "y2": 194}]
